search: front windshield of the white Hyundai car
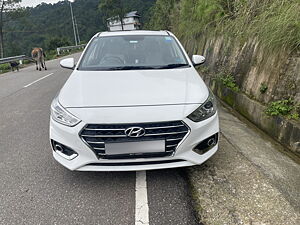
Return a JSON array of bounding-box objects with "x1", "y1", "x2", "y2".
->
[{"x1": 78, "y1": 35, "x2": 189, "y2": 71}]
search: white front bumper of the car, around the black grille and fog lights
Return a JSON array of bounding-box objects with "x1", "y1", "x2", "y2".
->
[{"x1": 50, "y1": 113, "x2": 219, "y2": 171}]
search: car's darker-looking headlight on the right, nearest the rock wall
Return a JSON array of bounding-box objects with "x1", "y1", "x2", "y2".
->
[{"x1": 188, "y1": 90, "x2": 217, "y2": 122}]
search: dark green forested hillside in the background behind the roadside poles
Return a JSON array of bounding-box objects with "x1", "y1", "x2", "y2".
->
[{"x1": 4, "y1": 0, "x2": 155, "y2": 57}]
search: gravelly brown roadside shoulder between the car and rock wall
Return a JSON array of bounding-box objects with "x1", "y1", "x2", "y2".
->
[{"x1": 188, "y1": 103, "x2": 300, "y2": 225}]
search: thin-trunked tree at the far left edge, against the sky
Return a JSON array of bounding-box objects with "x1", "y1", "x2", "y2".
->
[{"x1": 0, "y1": 0, "x2": 22, "y2": 58}]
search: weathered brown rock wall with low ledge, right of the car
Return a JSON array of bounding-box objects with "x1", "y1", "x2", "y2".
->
[{"x1": 183, "y1": 37, "x2": 300, "y2": 154}]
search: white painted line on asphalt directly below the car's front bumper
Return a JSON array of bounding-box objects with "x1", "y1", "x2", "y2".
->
[{"x1": 135, "y1": 171, "x2": 149, "y2": 225}]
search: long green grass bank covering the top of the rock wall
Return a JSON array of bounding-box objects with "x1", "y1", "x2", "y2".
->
[{"x1": 149, "y1": 0, "x2": 300, "y2": 51}]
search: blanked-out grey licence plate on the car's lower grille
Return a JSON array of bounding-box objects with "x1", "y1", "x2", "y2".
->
[{"x1": 105, "y1": 140, "x2": 165, "y2": 155}]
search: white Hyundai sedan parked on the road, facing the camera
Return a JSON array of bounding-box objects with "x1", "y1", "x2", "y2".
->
[{"x1": 50, "y1": 31, "x2": 219, "y2": 171}]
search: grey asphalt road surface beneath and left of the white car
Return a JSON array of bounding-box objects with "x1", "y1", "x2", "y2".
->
[{"x1": 0, "y1": 54, "x2": 197, "y2": 225}]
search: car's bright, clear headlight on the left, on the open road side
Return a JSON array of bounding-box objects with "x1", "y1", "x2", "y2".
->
[{"x1": 51, "y1": 97, "x2": 81, "y2": 127}]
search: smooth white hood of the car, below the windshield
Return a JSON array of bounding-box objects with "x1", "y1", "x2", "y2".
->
[{"x1": 59, "y1": 68, "x2": 208, "y2": 108}]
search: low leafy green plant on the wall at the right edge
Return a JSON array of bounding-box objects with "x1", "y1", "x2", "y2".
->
[{"x1": 266, "y1": 98, "x2": 299, "y2": 119}]
